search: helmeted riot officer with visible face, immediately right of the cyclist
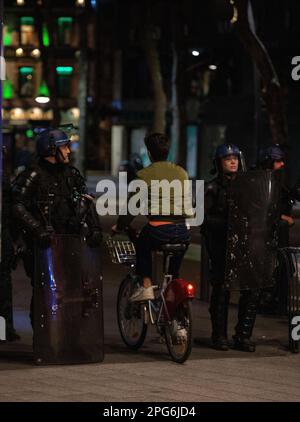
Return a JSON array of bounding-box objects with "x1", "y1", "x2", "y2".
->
[{"x1": 202, "y1": 144, "x2": 258, "y2": 352}]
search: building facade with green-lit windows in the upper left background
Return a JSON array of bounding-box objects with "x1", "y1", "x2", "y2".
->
[{"x1": 2, "y1": 0, "x2": 101, "y2": 171}]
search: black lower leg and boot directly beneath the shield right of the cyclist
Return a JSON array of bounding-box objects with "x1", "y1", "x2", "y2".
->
[{"x1": 233, "y1": 290, "x2": 259, "y2": 352}]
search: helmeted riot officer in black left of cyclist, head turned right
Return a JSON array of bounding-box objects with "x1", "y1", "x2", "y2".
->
[{"x1": 13, "y1": 129, "x2": 102, "y2": 326}]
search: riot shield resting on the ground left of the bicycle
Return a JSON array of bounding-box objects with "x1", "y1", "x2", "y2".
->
[{"x1": 33, "y1": 235, "x2": 104, "y2": 364}]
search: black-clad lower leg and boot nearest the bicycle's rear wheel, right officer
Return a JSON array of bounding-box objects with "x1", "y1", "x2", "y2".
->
[{"x1": 209, "y1": 286, "x2": 229, "y2": 351}]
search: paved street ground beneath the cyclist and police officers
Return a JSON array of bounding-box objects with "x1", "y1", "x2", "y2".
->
[{"x1": 0, "y1": 234, "x2": 300, "y2": 402}]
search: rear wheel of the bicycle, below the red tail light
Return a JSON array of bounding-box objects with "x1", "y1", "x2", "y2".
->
[{"x1": 165, "y1": 301, "x2": 192, "y2": 363}]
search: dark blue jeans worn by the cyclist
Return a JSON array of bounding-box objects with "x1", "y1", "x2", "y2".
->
[{"x1": 136, "y1": 224, "x2": 190, "y2": 279}]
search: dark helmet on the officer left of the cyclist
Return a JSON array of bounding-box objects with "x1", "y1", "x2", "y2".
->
[{"x1": 36, "y1": 129, "x2": 70, "y2": 157}]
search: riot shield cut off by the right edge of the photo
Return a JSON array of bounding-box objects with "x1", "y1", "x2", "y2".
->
[{"x1": 280, "y1": 248, "x2": 300, "y2": 353}]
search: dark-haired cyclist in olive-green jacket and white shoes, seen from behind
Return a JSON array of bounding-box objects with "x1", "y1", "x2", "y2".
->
[{"x1": 112, "y1": 133, "x2": 192, "y2": 302}]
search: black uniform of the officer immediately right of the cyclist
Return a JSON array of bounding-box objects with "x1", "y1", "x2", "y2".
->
[{"x1": 202, "y1": 175, "x2": 258, "y2": 343}]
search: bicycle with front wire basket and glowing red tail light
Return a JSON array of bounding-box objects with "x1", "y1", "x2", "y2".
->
[{"x1": 106, "y1": 231, "x2": 195, "y2": 363}]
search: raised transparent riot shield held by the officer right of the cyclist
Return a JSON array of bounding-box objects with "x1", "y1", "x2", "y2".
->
[{"x1": 225, "y1": 170, "x2": 281, "y2": 290}]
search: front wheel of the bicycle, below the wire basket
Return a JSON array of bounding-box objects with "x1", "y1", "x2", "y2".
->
[{"x1": 117, "y1": 276, "x2": 147, "y2": 350}]
